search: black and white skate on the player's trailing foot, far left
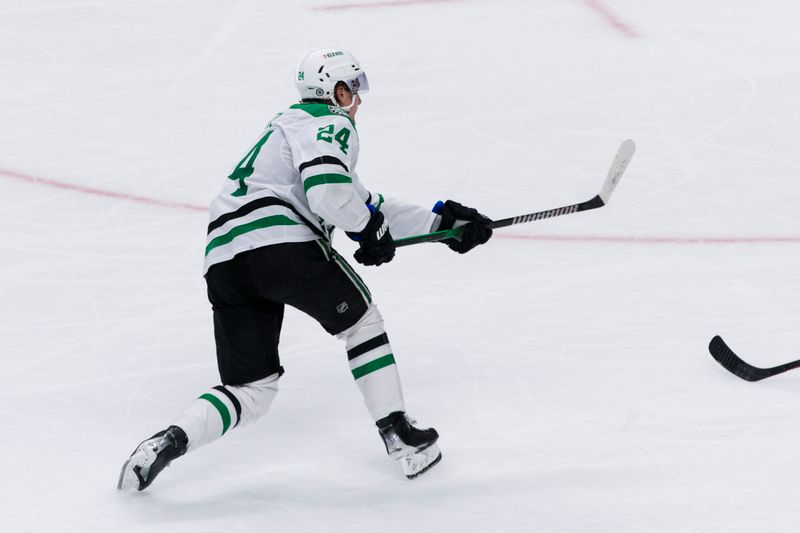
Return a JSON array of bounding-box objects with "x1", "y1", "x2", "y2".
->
[{"x1": 117, "y1": 426, "x2": 189, "y2": 490}]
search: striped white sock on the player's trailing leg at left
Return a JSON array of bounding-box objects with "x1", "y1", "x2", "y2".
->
[{"x1": 172, "y1": 374, "x2": 278, "y2": 451}]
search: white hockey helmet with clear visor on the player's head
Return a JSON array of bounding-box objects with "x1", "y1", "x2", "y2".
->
[{"x1": 294, "y1": 48, "x2": 369, "y2": 104}]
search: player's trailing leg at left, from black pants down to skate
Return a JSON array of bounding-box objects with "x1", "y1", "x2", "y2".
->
[{"x1": 117, "y1": 251, "x2": 284, "y2": 490}]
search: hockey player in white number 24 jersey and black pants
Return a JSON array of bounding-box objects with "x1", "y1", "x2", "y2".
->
[{"x1": 118, "y1": 49, "x2": 492, "y2": 490}]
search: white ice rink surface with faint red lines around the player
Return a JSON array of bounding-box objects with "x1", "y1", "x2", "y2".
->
[{"x1": 0, "y1": 0, "x2": 800, "y2": 532}]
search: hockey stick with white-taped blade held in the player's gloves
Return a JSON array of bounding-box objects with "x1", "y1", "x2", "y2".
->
[{"x1": 394, "y1": 139, "x2": 636, "y2": 247}]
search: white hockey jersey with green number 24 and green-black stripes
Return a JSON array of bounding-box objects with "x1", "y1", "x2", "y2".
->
[{"x1": 203, "y1": 103, "x2": 437, "y2": 274}]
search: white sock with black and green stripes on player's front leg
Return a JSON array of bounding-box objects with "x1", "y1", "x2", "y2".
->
[{"x1": 338, "y1": 305, "x2": 405, "y2": 420}]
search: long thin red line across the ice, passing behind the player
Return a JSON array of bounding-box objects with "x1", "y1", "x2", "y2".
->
[{"x1": 0, "y1": 168, "x2": 800, "y2": 245}]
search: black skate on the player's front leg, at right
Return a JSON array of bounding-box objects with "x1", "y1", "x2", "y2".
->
[{"x1": 375, "y1": 411, "x2": 442, "y2": 479}]
